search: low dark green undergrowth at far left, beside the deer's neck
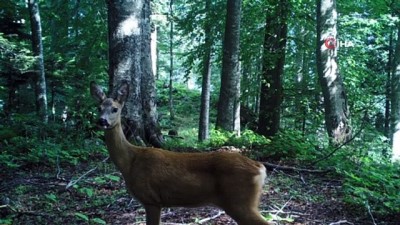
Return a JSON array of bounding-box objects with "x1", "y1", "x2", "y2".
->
[{"x1": 0, "y1": 114, "x2": 106, "y2": 168}]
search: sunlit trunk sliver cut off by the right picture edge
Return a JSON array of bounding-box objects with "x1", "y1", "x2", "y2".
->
[{"x1": 391, "y1": 23, "x2": 400, "y2": 161}]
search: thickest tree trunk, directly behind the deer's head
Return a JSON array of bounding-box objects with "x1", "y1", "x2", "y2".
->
[{"x1": 108, "y1": 0, "x2": 163, "y2": 147}]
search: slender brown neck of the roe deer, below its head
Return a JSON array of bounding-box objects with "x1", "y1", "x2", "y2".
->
[{"x1": 105, "y1": 122, "x2": 134, "y2": 174}]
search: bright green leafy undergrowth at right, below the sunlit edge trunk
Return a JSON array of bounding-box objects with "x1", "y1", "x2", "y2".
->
[{"x1": 310, "y1": 126, "x2": 400, "y2": 216}]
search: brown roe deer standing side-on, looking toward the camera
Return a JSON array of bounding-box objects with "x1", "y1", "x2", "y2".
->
[{"x1": 90, "y1": 82, "x2": 271, "y2": 225}]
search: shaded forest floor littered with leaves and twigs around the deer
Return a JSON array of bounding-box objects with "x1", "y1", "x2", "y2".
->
[{"x1": 0, "y1": 152, "x2": 400, "y2": 225}]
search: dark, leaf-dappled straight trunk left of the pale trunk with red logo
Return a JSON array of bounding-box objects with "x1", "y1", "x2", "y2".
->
[{"x1": 258, "y1": 0, "x2": 288, "y2": 136}]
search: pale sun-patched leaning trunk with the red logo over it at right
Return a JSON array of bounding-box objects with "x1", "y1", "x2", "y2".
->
[{"x1": 316, "y1": 0, "x2": 351, "y2": 145}]
